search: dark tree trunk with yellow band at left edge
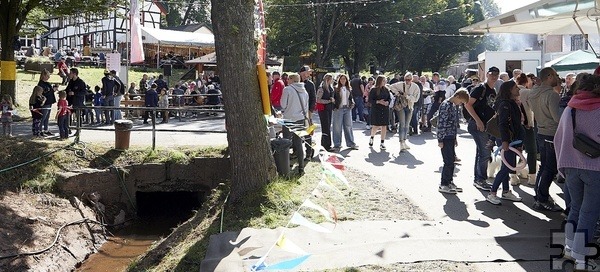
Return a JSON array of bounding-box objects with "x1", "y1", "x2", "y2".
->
[{"x1": 0, "y1": 1, "x2": 19, "y2": 102}]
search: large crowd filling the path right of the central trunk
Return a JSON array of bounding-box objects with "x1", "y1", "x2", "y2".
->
[{"x1": 270, "y1": 66, "x2": 600, "y2": 270}]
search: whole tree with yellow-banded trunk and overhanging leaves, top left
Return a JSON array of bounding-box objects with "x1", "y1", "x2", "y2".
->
[{"x1": 0, "y1": 0, "x2": 124, "y2": 102}]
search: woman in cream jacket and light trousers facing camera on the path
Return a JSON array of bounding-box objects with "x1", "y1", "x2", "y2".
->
[{"x1": 390, "y1": 72, "x2": 421, "y2": 152}]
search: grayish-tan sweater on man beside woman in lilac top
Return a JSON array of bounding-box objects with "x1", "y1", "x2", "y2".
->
[{"x1": 528, "y1": 85, "x2": 560, "y2": 136}]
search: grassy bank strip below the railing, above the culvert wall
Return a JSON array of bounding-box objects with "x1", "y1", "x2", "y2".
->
[{"x1": 0, "y1": 137, "x2": 225, "y2": 192}]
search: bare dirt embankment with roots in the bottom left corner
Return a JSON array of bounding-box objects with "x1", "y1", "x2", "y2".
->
[{"x1": 0, "y1": 192, "x2": 105, "y2": 271}]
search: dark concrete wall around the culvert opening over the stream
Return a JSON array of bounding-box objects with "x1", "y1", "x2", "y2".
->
[{"x1": 56, "y1": 158, "x2": 231, "y2": 224}]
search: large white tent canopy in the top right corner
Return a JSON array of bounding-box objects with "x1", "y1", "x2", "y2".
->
[{"x1": 460, "y1": 0, "x2": 600, "y2": 35}]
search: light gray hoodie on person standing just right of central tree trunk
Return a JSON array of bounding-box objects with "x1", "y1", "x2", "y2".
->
[{"x1": 281, "y1": 82, "x2": 308, "y2": 121}]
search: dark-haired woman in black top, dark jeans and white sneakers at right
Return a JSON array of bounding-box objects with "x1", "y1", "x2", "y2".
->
[{"x1": 486, "y1": 80, "x2": 525, "y2": 205}]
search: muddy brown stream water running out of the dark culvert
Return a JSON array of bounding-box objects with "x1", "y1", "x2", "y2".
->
[{"x1": 75, "y1": 217, "x2": 180, "y2": 272}]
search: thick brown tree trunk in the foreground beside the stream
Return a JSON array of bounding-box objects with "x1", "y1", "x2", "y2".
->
[{"x1": 211, "y1": 0, "x2": 276, "y2": 201}]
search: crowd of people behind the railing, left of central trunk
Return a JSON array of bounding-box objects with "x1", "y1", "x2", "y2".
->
[{"x1": 14, "y1": 67, "x2": 222, "y2": 139}]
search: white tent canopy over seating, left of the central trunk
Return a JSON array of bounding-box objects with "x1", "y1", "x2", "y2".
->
[{"x1": 142, "y1": 27, "x2": 215, "y2": 46}]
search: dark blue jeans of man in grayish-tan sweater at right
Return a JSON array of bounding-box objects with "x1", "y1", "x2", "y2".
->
[{"x1": 535, "y1": 134, "x2": 558, "y2": 202}]
